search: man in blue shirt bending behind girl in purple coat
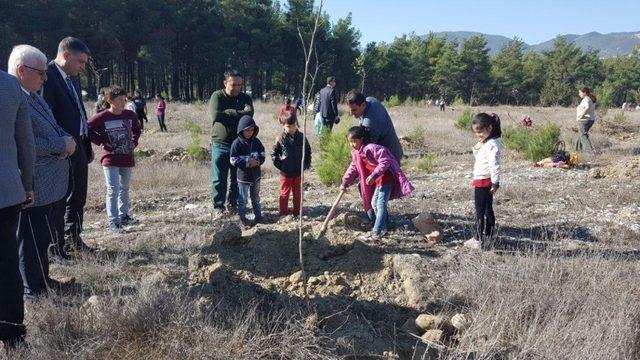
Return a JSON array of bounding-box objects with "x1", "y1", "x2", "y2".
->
[{"x1": 347, "y1": 90, "x2": 403, "y2": 164}]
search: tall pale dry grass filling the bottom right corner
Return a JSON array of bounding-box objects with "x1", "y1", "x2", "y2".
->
[{"x1": 447, "y1": 252, "x2": 640, "y2": 359}]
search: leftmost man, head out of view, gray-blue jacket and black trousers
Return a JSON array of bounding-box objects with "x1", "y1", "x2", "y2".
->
[{"x1": 0, "y1": 71, "x2": 35, "y2": 349}]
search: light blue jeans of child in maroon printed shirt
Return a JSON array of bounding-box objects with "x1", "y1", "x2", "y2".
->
[{"x1": 102, "y1": 166, "x2": 131, "y2": 224}]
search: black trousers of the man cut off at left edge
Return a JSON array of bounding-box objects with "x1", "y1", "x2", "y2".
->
[{"x1": 0, "y1": 206, "x2": 26, "y2": 344}]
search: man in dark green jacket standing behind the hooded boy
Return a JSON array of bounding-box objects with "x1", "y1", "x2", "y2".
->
[{"x1": 209, "y1": 70, "x2": 253, "y2": 218}]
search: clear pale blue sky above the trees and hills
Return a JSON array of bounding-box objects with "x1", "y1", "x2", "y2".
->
[{"x1": 324, "y1": 0, "x2": 640, "y2": 45}]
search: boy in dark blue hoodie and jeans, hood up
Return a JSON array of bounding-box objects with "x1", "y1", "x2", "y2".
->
[{"x1": 230, "y1": 115, "x2": 265, "y2": 226}]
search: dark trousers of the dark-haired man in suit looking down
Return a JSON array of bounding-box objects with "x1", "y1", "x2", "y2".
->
[{"x1": 62, "y1": 139, "x2": 91, "y2": 244}]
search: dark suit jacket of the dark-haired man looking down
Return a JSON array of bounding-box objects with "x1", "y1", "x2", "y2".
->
[{"x1": 42, "y1": 61, "x2": 93, "y2": 159}]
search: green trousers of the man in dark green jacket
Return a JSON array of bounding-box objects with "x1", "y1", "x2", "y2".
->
[{"x1": 211, "y1": 143, "x2": 238, "y2": 210}]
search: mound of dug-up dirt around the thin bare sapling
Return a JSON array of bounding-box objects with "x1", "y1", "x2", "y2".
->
[{"x1": 189, "y1": 212, "x2": 452, "y2": 353}]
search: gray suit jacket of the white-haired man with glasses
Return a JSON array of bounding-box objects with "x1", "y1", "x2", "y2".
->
[{"x1": 25, "y1": 94, "x2": 69, "y2": 206}]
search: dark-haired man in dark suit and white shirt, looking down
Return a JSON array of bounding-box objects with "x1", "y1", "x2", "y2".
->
[{"x1": 43, "y1": 37, "x2": 93, "y2": 258}]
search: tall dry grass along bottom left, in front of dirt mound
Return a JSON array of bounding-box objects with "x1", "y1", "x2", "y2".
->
[{"x1": 12, "y1": 285, "x2": 333, "y2": 359}]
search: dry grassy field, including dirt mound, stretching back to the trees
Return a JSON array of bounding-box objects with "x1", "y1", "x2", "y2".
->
[{"x1": 6, "y1": 103, "x2": 640, "y2": 359}]
